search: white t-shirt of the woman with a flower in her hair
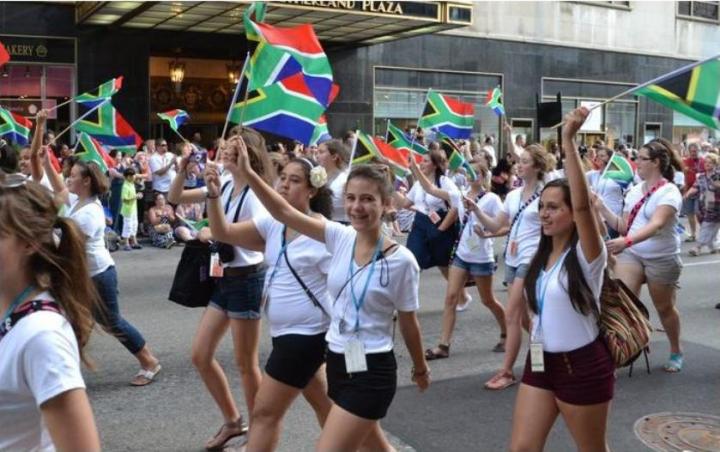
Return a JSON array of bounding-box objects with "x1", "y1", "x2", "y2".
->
[{"x1": 253, "y1": 216, "x2": 332, "y2": 337}]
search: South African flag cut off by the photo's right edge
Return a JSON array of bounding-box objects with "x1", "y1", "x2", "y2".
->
[{"x1": 634, "y1": 57, "x2": 720, "y2": 130}]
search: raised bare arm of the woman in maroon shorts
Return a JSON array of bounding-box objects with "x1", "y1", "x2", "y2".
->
[{"x1": 562, "y1": 107, "x2": 603, "y2": 262}]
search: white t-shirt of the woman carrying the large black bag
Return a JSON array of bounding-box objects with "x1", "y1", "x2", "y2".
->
[{"x1": 203, "y1": 174, "x2": 270, "y2": 267}]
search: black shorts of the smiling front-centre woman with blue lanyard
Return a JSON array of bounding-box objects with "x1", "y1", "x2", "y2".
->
[{"x1": 327, "y1": 350, "x2": 397, "y2": 421}]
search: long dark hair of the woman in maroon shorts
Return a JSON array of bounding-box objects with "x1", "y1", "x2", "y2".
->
[{"x1": 525, "y1": 178, "x2": 600, "y2": 316}]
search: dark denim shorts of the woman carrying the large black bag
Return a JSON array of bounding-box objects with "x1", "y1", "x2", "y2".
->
[{"x1": 208, "y1": 270, "x2": 265, "y2": 320}]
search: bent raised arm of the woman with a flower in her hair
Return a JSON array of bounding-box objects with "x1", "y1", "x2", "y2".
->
[{"x1": 205, "y1": 162, "x2": 265, "y2": 251}]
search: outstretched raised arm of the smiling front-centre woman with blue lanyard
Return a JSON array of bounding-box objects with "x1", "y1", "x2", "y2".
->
[{"x1": 227, "y1": 135, "x2": 325, "y2": 243}]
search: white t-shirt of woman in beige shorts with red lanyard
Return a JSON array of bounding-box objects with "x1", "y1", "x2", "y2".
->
[{"x1": 623, "y1": 182, "x2": 682, "y2": 259}]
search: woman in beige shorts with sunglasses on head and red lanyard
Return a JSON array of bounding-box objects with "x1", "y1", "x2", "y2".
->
[{"x1": 600, "y1": 139, "x2": 683, "y2": 372}]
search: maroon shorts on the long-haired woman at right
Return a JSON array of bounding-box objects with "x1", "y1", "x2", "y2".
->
[{"x1": 522, "y1": 336, "x2": 615, "y2": 405}]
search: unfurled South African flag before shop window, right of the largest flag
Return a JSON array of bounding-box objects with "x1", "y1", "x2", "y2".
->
[{"x1": 418, "y1": 90, "x2": 475, "y2": 139}]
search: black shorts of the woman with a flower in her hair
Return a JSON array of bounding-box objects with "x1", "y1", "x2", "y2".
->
[{"x1": 265, "y1": 333, "x2": 327, "y2": 389}]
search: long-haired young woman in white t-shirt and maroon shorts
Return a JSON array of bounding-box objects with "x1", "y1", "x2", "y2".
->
[{"x1": 510, "y1": 108, "x2": 615, "y2": 451}]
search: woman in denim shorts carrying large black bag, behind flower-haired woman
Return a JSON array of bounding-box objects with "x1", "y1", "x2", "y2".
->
[{"x1": 168, "y1": 126, "x2": 274, "y2": 449}]
